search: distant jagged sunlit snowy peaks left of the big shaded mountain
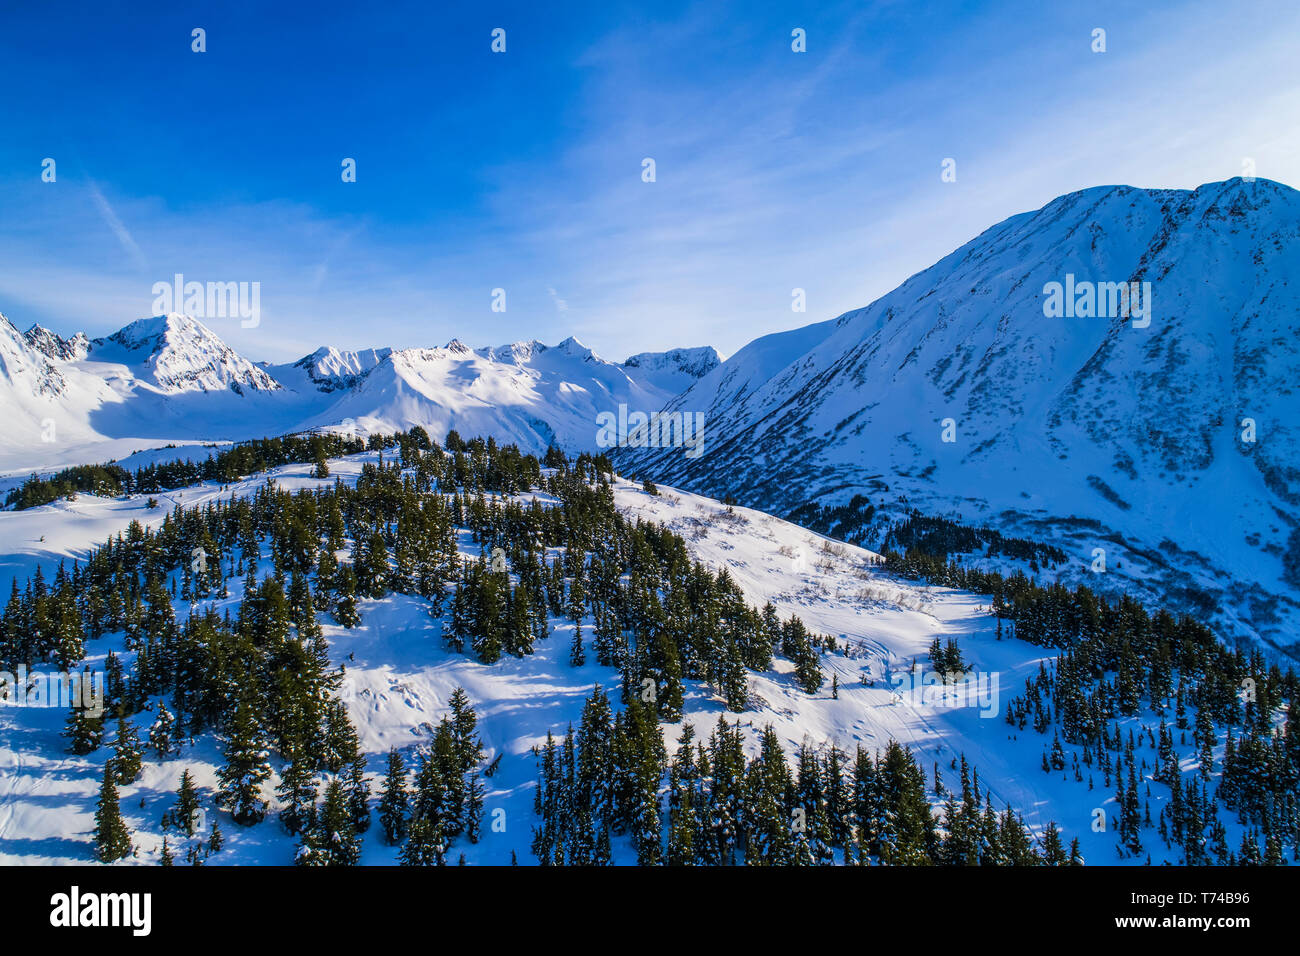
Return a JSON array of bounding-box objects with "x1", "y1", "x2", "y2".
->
[{"x1": 0, "y1": 313, "x2": 718, "y2": 471}]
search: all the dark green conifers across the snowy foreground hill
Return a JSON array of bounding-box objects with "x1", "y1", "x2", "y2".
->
[{"x1": 20, "y1": 418, "x2": 1300, "y2": 865}]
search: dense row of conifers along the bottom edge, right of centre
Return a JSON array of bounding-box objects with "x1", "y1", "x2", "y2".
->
[{"x1": 532, "y1": 688, "x2": 1083, "y2": 866}]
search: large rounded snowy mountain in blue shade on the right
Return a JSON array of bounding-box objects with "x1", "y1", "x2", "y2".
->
[{"x1": 619, "y1": 179, "x2": 1300, "y2": 650}]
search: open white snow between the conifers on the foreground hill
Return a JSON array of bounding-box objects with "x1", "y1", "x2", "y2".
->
[{"x1": 0, "y1": 453, "x2": 1239, "y2": 865}]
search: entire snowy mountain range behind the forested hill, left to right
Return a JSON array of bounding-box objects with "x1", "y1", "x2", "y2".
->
[{"x1": 0, "y1": 179, "x2": 1300, "y2": 665}]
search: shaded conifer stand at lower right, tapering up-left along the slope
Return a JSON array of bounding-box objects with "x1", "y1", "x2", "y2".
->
[{"x1": 885, "y1": 520, "x2": 1300, "y2": 865}]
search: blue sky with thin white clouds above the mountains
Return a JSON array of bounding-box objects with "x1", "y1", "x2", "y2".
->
[{"x1": 0, "y1": 0, "x2": 1300, "y2": 360}]
